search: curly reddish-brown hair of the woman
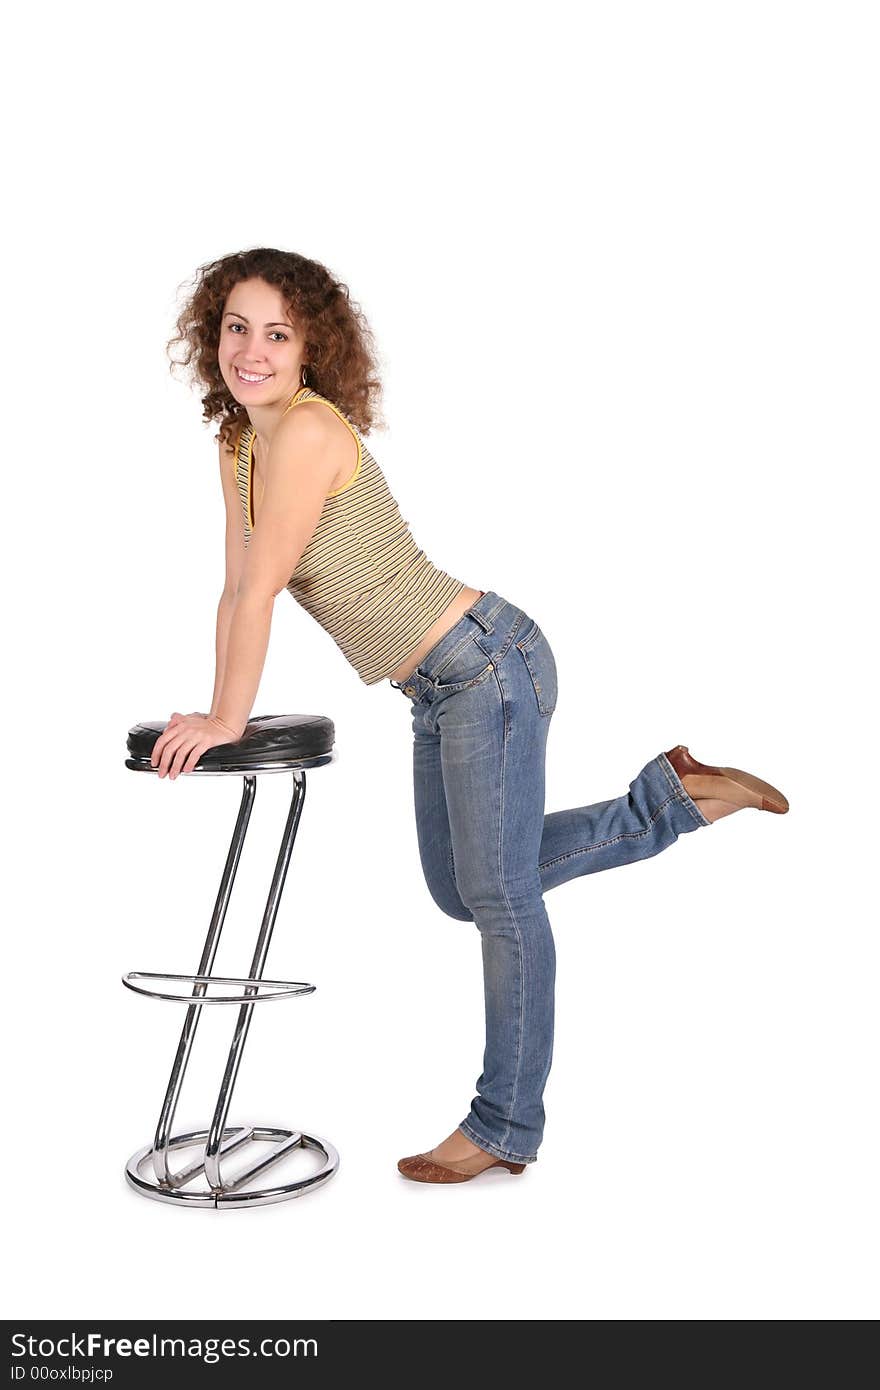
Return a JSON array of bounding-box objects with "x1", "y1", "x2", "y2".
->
[{"x1": 167, "y1": 246, "x2": 384, "y2": 446}]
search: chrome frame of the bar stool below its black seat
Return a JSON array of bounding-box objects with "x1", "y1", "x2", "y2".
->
[{"x1": 122, "y1": 733, "x2": 339, "y2": 1208}]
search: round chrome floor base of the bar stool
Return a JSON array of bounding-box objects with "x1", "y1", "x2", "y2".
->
[{"x1": 125, "y1": 1125, "x2": 339, "y2": 1209}]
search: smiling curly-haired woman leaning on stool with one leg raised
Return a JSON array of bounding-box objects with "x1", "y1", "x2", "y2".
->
[{"x1": 153, "y1": 249, "x2": 788, "y2": 1183}]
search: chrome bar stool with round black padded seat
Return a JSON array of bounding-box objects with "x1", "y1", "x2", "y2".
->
[{"x1": 122, "y1": 714, "x2": 339, "y2": 1209}]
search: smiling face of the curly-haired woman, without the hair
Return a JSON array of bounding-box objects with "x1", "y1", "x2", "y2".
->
[{"x1": 218, "y1": 279, "x2": 306, "y2": 406}]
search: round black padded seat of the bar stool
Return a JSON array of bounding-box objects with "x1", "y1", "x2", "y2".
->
[{"x1": 125, "y1": 714, "x2": 336, "y2": 777}]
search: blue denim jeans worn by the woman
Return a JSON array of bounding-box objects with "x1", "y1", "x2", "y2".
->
[{"x1": 391, "y1": 591, "x2": 710, "y2": 1163}]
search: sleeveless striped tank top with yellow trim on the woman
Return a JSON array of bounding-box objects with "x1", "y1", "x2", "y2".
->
[{"x1": 235, "y1": 386, "x2": 466, "y2": 685}]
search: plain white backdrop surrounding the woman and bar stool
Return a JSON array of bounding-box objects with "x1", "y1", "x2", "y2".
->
[{"x1": 3, "y1": 0, "x2": 880, "y2": 1319}]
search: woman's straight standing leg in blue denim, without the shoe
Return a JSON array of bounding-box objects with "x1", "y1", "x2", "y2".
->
[{"x1": 427, "y1": 661, "x2": 556, "y2": 1163}]
